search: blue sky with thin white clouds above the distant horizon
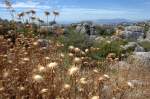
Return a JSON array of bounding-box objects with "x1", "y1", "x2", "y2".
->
[{"x1": 0, "y1": 0, "x2": 150, "y2": 21}]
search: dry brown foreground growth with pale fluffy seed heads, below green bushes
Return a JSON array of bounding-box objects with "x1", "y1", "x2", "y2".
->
[{"x1": 0, "y1": 34, "x2": 150, "y2": 99}]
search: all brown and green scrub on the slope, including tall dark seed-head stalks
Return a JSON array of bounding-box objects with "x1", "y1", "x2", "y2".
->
[{"x1": 0, "y1": 0, "x2": 150, "y2": 99}]
